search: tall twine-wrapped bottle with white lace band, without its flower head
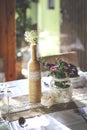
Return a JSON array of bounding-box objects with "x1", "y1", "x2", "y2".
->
[{"x1": 28, "y1": 44, "x2": 41, "y2": 103}]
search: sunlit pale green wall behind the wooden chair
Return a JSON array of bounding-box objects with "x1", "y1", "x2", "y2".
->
[{"x1": 37, "y1": 0, "x2": 60, "y2": 56}]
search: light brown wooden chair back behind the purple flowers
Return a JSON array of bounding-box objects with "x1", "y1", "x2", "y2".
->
[{"x1": 39, "y1": 51, "x2": 79, "y2": 71}]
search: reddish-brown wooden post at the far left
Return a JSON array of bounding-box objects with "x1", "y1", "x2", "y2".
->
[{"x1": 0, "y1": 0, "x2": 16, "y2": 81}]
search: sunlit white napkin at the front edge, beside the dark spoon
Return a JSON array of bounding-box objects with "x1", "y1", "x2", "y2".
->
[{"x1": 12, "y1": 115, "x2": 70, "y2": 130}]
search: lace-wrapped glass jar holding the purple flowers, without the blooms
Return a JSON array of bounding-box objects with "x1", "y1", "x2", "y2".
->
[{"x1": 51, "y1": 78, "x2": 72, "y2": 103}]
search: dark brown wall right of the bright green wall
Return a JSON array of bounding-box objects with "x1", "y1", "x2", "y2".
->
[{"x1": 60, "y1": 0, "x2": 87, "y2": 71}]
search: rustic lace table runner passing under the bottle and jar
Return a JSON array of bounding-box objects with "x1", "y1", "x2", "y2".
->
[{"x1": 1, "y1": 87, "x2": 87, "y2": 120}]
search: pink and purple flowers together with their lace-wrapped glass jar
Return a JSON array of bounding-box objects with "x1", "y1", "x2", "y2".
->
[{"x1": 42, "y1": 58, "x2": 79, "y2": 103}]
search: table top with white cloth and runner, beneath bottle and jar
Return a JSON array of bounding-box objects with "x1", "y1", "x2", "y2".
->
[{"x1": 0, "y1": 77, "x2": 87, "y2": 130}]
